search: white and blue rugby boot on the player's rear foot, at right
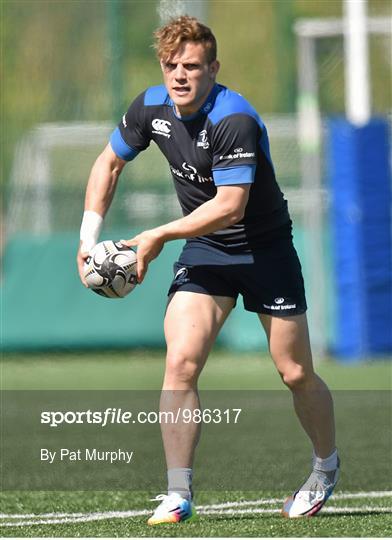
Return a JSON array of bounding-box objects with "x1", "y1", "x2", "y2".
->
[{"x1": 282, "y1": 458, "x2": 340, "y2": 518}]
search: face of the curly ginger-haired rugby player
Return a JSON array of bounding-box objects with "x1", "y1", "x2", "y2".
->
[{"x1": 161, "y1": 41, "x2": 219, "y2": 116}]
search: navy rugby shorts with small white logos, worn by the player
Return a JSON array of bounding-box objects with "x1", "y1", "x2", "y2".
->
[{"x1": 168, "y1": 227, "x2": 307, "y2": 317}]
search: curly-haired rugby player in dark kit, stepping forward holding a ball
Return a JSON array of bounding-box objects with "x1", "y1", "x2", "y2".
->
[{"x1": 77, "y1": 16, "x2": 339, "y2": 525}]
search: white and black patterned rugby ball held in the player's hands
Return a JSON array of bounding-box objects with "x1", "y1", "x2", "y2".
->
[{"x1": 84, "y1": 240, "x2": 137, "y2": 298}]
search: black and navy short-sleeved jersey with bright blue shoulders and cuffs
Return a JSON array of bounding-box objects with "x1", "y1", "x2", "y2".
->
[{"x1": 110, "y1": 84, "x2": 290, "y2": 251}]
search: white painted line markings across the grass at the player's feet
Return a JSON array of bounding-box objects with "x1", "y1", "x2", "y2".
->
[{"x1": 0, "y1": 491, "x2": 392, "y2": 527}]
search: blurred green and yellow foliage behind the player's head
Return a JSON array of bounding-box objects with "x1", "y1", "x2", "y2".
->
[{"x1": 1, "y1": 0, "x2": 391, "y2": 189}]
